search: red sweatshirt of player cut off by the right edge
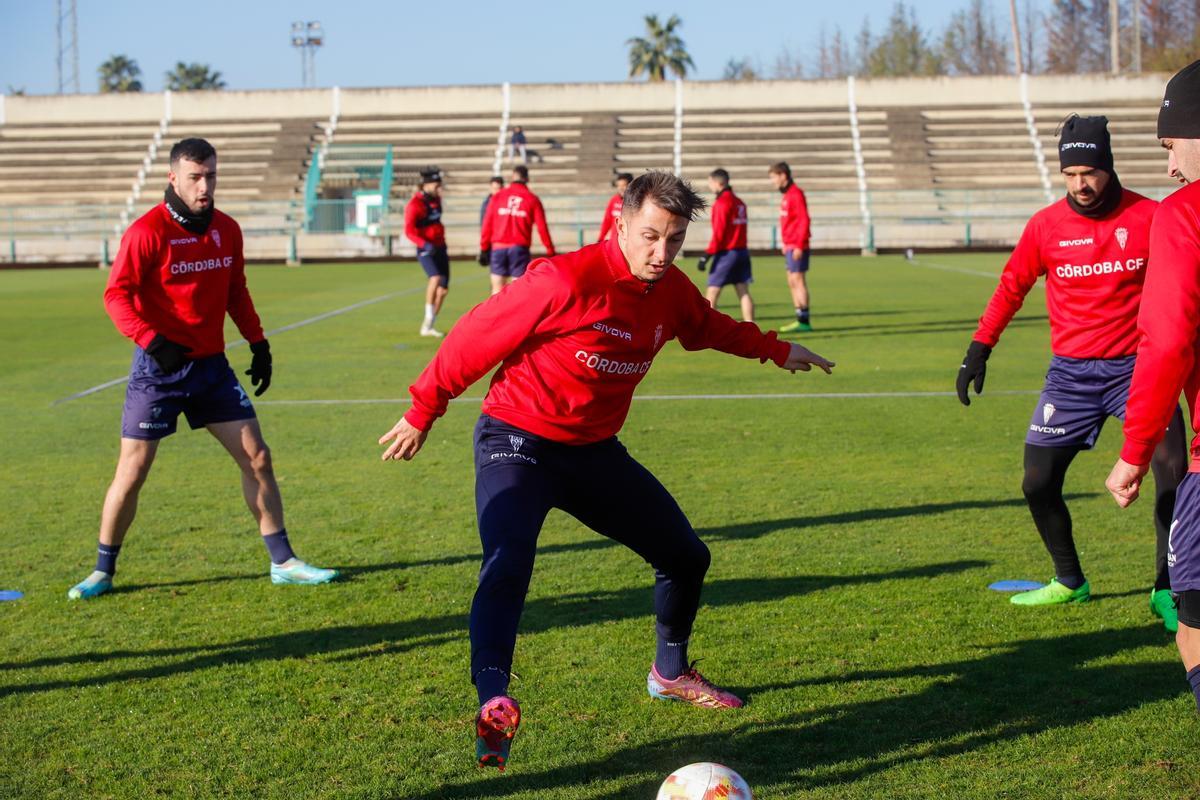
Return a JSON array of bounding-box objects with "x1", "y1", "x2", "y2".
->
[{"x1": 1121, "y1": 184, "x2": 1200, "y2": 473}]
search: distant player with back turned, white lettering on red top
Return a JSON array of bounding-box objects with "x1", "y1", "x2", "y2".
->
[{"x1": 479, "y1": 164, "x2": 554, "y2": 294}]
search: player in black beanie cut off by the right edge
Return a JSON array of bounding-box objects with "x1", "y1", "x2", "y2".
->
[{"x1": 1105, "y1": 61, "x2": 1200, "y2": 709}]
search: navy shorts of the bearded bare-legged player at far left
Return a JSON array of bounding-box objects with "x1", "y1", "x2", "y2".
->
[{"x1": 121, "y1": 348, "x2": 256, "y2": 440}]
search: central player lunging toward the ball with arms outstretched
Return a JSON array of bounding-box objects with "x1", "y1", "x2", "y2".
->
[{"x1": 379, "y1": 173, "x2": 834, "y2": 768}]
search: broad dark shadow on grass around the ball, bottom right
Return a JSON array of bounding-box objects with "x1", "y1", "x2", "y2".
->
[{"x1": 407, "y1": 627, "x2": 1184, "y2": 800}]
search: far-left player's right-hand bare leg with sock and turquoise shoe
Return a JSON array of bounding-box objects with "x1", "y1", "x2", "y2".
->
[{"x1": 206, "y1": 419, "x2": 337, "y2": 584}]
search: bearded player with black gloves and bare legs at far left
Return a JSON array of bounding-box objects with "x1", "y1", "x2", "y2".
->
[{"x1": 67, "y1": 139, "x2": 337, "y2": 600}]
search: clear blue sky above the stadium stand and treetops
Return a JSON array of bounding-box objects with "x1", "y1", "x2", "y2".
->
[{"x1": 0, "y1": 0, "x2": 979, "y2": 95}]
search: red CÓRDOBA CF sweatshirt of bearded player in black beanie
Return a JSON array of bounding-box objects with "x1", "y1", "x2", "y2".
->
[{"x1": 974, "y1": 190, "x2": 1158, "y2": 359}]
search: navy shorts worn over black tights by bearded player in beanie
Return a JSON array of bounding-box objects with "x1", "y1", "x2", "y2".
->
[{"x1": 1025, "y1": 355, "x2": 1134, "y2": 450}]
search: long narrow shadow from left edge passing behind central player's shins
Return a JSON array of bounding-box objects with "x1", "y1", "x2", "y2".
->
[{"x1": 0, "y1": 560, "x2": 988, "y2": 697}]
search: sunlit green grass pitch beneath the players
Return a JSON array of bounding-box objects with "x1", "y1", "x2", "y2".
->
[{"x1": 0, "y1": 254, "x2": 1200, "y2": 800}]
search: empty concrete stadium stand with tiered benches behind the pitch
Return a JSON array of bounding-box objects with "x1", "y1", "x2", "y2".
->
[{"x1": 0, "y1": 74, "x2": 1171, "y2": 260}]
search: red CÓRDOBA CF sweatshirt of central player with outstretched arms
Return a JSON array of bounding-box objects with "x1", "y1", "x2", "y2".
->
[{"x1": 404, "y1": 239, "x2": 791, "y2": 445}]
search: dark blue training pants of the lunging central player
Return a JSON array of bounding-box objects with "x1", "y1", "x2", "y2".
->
[{"x1": 470, "y1": 415, "x2": 709, "y2": 680}]
